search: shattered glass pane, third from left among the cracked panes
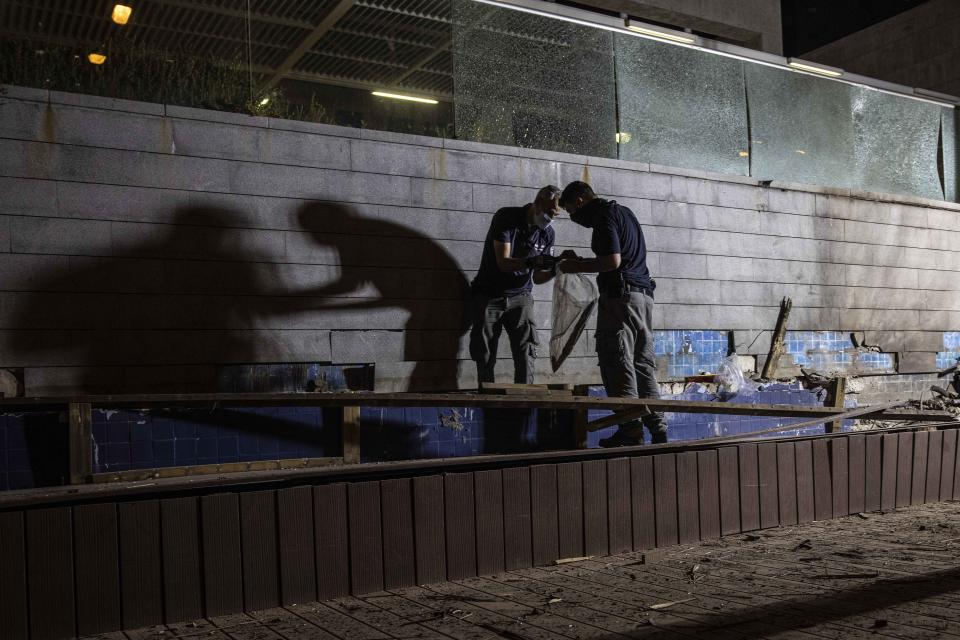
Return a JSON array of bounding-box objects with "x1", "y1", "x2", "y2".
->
[{"x1": 745, "y1": 63, "x2": 855, "y2": 187}]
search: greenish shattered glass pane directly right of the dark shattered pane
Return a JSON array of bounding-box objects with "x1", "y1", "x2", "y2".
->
[{"x1": 614, "y1": 34, "x2": 750, "y2": 176}]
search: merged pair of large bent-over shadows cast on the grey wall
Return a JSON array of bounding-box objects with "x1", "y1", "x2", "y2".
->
[{"x1": 9, "y1": 202, "x2": 468, "y2": 393}]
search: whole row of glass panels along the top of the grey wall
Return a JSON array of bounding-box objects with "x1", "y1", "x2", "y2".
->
[{"x1": 0, "y1": 0, "x2": 958, "y2": 201}]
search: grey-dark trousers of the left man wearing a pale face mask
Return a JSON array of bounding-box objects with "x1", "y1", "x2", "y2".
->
[{"x1": 470, "y1": 293, "x2": 539, "y2": 384}]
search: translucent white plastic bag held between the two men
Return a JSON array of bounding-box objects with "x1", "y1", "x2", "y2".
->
[{"x1": 550, "y1": 273, "x2": 599, "y2": 371}]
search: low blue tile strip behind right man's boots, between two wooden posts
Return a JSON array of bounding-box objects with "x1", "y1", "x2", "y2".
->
[{"x1": 587, "y1": 382, "x2": 828, "y2": 448}]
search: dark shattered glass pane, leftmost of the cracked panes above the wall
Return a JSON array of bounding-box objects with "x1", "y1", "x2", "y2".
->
[{"x1": 453, "y1": 0, "x2": 617, "y2": 158}]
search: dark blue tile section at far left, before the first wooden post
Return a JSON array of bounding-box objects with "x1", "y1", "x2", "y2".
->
[{"x1": 0, "y1": 411, "x2": 69, "y2": 490}]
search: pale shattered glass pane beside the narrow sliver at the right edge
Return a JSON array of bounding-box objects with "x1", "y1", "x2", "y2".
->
[{"x1": 852, "y1": 83, "x2": 943, "y2": 200}]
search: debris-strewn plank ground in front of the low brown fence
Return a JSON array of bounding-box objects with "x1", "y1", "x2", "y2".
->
[{"x1": 84, "y1": 503, "x2": 960, "y2": 640}]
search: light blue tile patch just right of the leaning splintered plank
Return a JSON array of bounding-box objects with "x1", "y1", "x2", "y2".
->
[{"x1": 785, "y1": 331, "x2": 894, "y2": 372}]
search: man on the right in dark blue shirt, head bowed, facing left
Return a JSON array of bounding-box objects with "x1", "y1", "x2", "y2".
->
[{"x1": 558, "y1": 182, "x2": 667, "y2": 447}]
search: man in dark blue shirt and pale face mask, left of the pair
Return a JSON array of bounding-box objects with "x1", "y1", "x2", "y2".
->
[{"x1": 470, "y1": 186, "x2": 560, "y2": 386}]
